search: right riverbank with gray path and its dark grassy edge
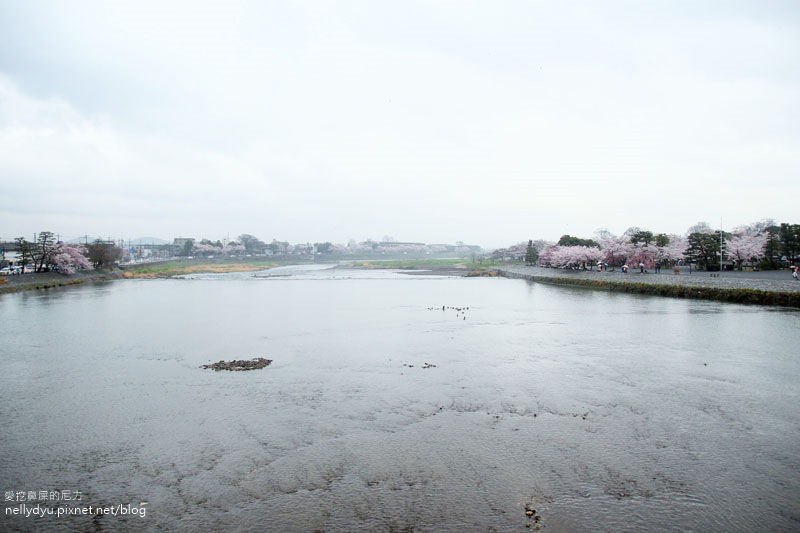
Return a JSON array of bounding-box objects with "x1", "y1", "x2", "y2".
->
[{"x1": 498, "y1": 265, "x2": 800, "y2": 308}]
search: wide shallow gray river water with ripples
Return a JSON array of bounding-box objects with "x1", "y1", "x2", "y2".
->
[{"x1": 0, "y1": 267, "x2": 800, "y2": 531}]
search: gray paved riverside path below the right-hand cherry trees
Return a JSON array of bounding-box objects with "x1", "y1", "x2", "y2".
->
[{"x1": 497, "y1": 265, "x2": 800, "y2": 292}]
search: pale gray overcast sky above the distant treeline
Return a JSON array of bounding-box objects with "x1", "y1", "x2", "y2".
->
[{"x1": 0, "y1": 0, "x2": 800, "y2": 246}]
